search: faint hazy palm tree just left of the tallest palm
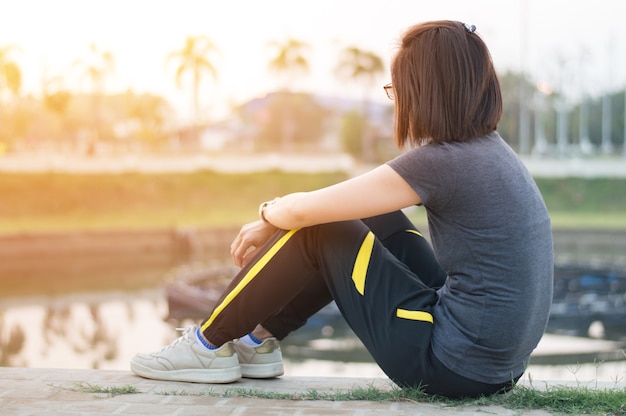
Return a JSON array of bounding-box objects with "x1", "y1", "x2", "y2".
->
[{"x1": 74, "y1": 43, "x2": 115, "y2": 149}]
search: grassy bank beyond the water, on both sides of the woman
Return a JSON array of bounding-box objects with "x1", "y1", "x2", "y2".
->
[{"x1": 0, "y1": 171, "x2": 626, "y2": 233}]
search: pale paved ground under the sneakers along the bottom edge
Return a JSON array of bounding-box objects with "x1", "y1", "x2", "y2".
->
[{"x1": 0, "y1": 367, "x2": 564, "y2": 416}]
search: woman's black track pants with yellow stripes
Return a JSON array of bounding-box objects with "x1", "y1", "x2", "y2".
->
[{"x1": 202, "y1": 212, "x2": 516, "y2": 396}]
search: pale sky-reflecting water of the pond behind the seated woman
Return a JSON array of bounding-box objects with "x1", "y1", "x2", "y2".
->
[{"x1": 0, "y1": 288, "x2": 626, "y2": 385}]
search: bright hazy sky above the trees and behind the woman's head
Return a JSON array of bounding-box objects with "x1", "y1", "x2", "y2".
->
[{"x1": 0, "y1": 0, "x2": 626, "y2": 117}]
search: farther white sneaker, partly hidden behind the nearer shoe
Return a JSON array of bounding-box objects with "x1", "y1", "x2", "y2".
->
[{"x1": 234, "y1": 338, "x2": 285, "y2": 378}]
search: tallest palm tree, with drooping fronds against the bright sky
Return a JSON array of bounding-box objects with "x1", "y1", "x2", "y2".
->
[{"x1": 166, "y1": 36, "x2": 218, "y2": 124}]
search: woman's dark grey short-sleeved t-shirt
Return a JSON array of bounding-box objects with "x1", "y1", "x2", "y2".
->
[{"x1": 388, "y1": 132, "x2": 554, "y2": 384}]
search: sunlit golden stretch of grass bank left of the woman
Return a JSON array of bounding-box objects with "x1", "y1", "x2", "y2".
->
[{"x1": 0, "y1": 171, "x2": 346, "y2": 233}]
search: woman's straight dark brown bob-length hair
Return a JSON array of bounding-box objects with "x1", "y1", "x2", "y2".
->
[{"x1": 391, "y1": 20, "x2": 502, "y2": 147}]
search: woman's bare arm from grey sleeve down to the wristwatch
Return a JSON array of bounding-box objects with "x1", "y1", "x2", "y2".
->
[{"x1": 263, "y1": 165, "x2": 421, "y2": 230}]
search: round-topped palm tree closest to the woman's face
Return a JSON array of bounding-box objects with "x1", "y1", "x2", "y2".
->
[{"x1": 336, "y1": 46, "x2": 385, "y2": 162}]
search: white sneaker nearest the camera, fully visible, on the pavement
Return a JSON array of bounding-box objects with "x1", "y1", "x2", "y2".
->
[{"x1": 130, "y1": 326, "x2": 241, "y2": 383}]
